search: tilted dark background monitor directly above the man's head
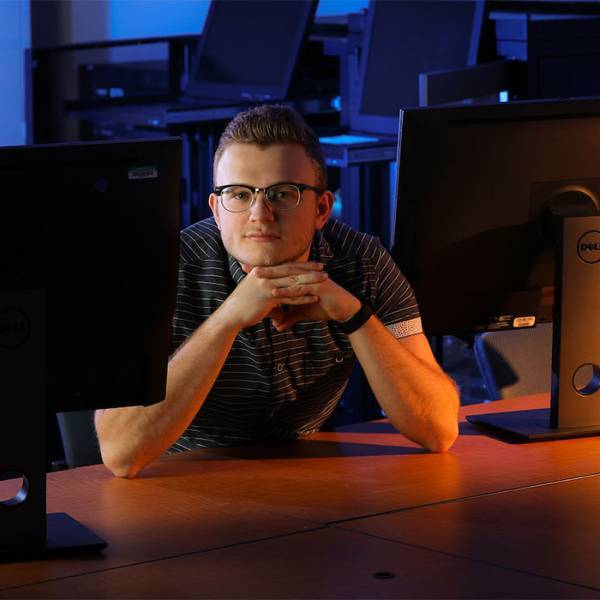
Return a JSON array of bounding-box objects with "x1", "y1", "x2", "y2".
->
[{"x1": 185, "y1": 0, "x2": 317, "y2": 102}]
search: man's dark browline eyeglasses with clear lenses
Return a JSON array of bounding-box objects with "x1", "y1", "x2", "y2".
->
[{"x1": 213, "y1": 183, "x2": 323, "y2": 212}]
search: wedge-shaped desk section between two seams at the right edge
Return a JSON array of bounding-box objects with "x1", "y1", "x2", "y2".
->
[{"x1": 341, "y1": 474, "x2": 600, "y2": 590}]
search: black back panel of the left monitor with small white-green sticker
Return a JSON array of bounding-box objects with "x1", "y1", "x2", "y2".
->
[{"x1": 0, "y1": 139, "x2": 181, "y2": 411}]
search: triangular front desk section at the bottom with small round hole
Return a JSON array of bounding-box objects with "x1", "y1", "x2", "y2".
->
[{"x1": 0, "y1": 528, "x2": 600, "y2": 598}]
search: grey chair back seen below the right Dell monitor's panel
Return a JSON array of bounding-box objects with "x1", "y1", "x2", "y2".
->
[{"x1": 474, "y1": 323, "x2": 552, "y2": 400}]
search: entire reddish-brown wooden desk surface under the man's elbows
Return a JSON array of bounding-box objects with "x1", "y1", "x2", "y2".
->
[{"x1": 0, "y1": 396, "x2": 600, "y2": 597}]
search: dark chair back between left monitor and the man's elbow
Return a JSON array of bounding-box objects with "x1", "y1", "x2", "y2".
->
[{"x1": 56, "y1": 410, "x2": 102, "y2": 469}]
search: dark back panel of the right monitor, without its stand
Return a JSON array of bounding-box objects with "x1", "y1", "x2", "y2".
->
[{"x1": 393, "y1": 99, "x2": 600, "y2": 335}]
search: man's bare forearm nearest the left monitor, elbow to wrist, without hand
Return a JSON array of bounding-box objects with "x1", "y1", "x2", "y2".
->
[{"x1": 96, "y1": 310, "x2": 239, "y2": 477}]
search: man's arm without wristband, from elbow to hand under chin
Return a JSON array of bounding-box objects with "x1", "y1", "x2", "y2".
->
[{"x1": 96, "y1": 262, "x2": 327, "y2": 477}]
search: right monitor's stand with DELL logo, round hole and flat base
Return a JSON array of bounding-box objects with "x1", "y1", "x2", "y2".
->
[{"x1": 467, "y1": 209, "x2": 600, "y2": 442}]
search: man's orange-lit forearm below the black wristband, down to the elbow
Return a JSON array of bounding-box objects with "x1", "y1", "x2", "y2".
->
[{"x1": 349, "y1": 317, "x2": 459, "y2": 452}]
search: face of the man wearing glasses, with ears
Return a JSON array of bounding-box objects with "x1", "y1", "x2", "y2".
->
[{"x1": 209, "y1": 144, "x2": 333, "y2": 266}]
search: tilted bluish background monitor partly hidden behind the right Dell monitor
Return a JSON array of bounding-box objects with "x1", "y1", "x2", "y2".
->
[{"x1": 350, "y1": 0, "x2": 484, "y2": 136}]
